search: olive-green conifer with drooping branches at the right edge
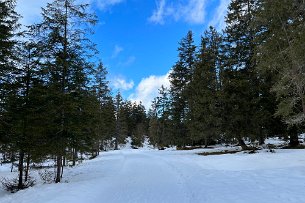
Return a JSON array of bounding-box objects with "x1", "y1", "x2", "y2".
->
[{"x1": 255, "y1": 0, "x2": 305, "y2": 146}]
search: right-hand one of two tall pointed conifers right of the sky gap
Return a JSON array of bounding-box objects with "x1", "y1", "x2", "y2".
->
[{"x1": 188, "y1": 27, "x2": 222, "y2": 147}]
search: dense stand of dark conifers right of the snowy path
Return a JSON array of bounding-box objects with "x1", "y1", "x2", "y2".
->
[{"x1": 148, "y1": 0, "x2": 305, "y2": 149}]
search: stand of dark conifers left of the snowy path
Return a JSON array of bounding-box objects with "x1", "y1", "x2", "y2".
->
[{"x1": 0, "y1": 0, "x2": 148, "y2": 189}]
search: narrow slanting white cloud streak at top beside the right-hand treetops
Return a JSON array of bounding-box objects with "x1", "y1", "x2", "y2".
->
[{"x1": 209, "y1": 0, "x2": 230, "y2": 30}]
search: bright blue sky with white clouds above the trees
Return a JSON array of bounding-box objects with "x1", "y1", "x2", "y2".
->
[{"x1": 17, "y1": 0, "x2": 229, "y2": 107}]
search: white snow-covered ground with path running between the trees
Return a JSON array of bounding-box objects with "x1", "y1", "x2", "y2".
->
[{"x1": 0, "y1": 146, "x2": 305, "y2": 203}]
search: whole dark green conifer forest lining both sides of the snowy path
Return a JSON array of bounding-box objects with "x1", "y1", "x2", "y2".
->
[{"x1": 0, "y1": 0, "x2": 305, "y2": 202}]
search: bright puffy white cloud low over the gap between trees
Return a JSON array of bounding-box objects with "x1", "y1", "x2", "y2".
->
[{"x1": 128, "y1": 73, "x2": 170, "y2": 109}]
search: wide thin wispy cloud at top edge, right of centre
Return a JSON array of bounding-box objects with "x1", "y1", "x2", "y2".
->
[{"x1": 148, "y1": 0, "x2": 206, "y2": 24}]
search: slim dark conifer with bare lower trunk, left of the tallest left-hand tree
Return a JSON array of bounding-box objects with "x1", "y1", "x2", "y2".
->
[{"x1": 10, "y1": 42, "x2": 42, "y2": 189}]
